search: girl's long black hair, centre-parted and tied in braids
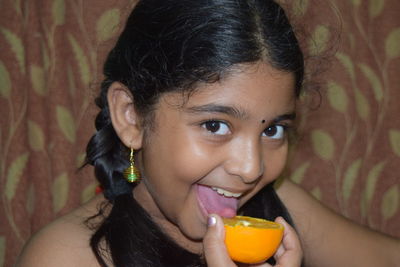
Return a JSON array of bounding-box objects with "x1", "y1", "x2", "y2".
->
[{"x1": 86, "y1": 0, "x2": 304, "y2": 266}]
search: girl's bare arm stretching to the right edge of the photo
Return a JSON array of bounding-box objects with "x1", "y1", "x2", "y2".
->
[{"x1": 277, "y1": 180, "x2": 400, "y2": 267}]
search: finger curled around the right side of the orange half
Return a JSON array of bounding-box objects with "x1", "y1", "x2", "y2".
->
[{"x1": 274, "y1": 217, "x2": 303, "y2": 266}]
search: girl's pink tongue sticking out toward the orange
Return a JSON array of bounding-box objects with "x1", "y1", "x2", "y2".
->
[{"x1": 197, "y1": 185, "x2": 238, "y2": 218}]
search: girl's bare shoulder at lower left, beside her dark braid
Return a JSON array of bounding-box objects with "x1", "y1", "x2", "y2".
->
[{"x1": 16, "y1": 196, "x2": 108, "y2": 267}]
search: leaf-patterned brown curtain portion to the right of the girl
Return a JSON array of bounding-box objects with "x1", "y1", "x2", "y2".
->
[{"x1": 286, "y1": 0, "x2": 400, "y2": 230}]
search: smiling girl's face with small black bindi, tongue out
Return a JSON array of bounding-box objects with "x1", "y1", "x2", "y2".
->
[{"x1": 134, "y1": 63, "x2": 295, "y2": 251}]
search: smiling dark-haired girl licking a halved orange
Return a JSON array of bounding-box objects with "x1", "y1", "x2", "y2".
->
[{"x1": 18, "y1": 0, "x2": 399, "y2": 267}]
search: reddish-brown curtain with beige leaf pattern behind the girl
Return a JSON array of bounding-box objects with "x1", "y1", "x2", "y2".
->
[{"x1": 0, "y1": 0, "x2": 400, "y2": 266}]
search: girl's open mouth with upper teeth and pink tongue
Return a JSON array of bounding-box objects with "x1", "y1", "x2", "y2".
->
[{"x1": 196, "y1": 184, "x2": 242, "y2": 218}]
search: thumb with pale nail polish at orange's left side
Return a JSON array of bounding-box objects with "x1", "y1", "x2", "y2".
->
[{"x1": 203, "y1": 214, "x2": 236, "y2": 267}]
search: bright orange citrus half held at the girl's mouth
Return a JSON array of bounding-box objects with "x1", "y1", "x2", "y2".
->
[{"x1": 223, "y1": 216, "x2": 283, "y2": 264}]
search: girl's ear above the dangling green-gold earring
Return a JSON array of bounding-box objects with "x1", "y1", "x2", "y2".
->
[{"x1": 107, "y1": 82, "x2": 143, "y2": 150}]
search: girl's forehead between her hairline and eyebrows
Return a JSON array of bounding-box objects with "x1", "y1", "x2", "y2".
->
[{"x1": 164, "y1": 63, "x2": 295, "y2": 116}]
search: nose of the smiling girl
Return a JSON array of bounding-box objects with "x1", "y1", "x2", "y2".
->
[{"x1": 225, "y1": 140, "x2": 264, "y2": 183}]
